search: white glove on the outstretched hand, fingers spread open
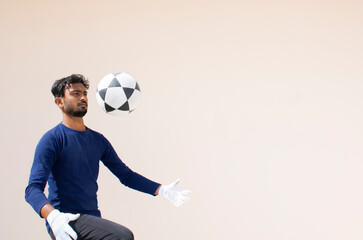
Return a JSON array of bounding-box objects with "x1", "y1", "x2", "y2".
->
[{"x1": 158, "y1": 179, "x2": 192, "y2": 207}]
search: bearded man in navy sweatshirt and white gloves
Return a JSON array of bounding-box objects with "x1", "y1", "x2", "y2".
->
[{"x1": 25, "y1": 74, "x2": 190, "y2": 240}]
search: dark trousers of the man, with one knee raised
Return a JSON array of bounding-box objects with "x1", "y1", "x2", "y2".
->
[{"x1": 49, "y1": 214, "x2": 134, "y2": 240}]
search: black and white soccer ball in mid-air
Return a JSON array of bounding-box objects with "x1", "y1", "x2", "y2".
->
[{"x1": 96, "y1": 72, "x2": 141, "y2": 116}]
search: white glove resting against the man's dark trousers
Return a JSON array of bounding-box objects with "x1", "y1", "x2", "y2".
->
[{"x1": 47, "y1": 209, "x2": 80, "y2": 240}]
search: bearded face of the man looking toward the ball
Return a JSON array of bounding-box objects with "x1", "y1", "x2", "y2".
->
[{"x1": 62, "y1": 83, "x2": 88, "y2": 117}]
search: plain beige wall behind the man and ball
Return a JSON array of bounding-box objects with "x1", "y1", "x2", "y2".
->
[{"x1": 0, "y1": 0, "x2": 363, "y2": 240}]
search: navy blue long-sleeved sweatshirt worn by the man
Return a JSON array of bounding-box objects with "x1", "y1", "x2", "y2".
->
[{"x1": 25, "y1": 123, "x2": 160, "y2": 217}]
